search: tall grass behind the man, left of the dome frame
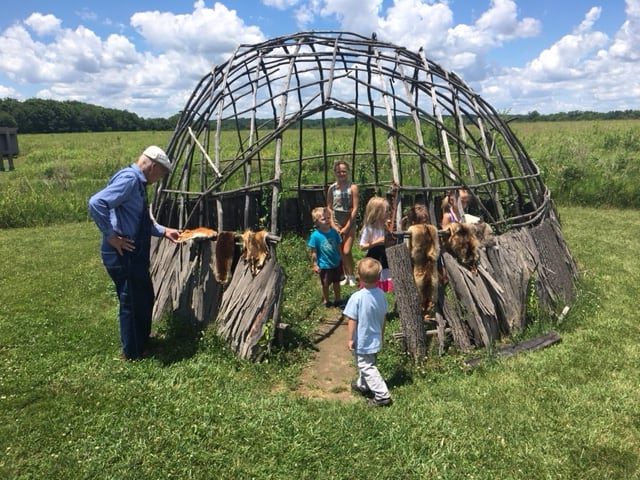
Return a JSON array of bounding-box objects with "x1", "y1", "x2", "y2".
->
[{"x1": 0, "y1": 132, "x2": 171, "y2": 228}]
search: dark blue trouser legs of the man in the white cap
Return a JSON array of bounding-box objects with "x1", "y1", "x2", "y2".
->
[{"x1": 102, "y1": 247, "x2": 154, "y2": 360}]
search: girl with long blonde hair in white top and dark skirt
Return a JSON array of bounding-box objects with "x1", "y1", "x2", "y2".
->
[{"x1": 360, "y1": 197, "x2": 393, "y2": 292}]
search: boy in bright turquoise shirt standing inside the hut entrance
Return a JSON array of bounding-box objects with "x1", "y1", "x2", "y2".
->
[{"x1": 307, "y1": 207, "x2": 342, "y2": 307}]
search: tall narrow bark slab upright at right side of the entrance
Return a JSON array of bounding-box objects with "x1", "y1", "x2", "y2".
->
[{"x1": 387, "y1": 243, "x2": 427, "y2": 362}]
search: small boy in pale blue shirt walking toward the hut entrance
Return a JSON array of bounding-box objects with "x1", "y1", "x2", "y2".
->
[{"x1": 342, "y1": 257, "x2": 392, "y2": 407}]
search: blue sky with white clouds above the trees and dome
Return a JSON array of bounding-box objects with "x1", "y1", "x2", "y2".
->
[{"x1": 0, "y1": 0, "x2": 640, "y2": 118}]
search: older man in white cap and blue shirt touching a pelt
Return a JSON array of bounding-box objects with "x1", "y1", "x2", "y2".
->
[{"x1": 89, "y1": 145, "x2": 179, "y2": 360}]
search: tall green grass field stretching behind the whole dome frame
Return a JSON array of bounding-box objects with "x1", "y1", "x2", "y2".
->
[{"x1": 0, "y1": 120, "x2": 640, "y2": 228}]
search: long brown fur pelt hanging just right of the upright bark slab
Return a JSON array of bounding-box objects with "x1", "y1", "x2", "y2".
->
[{"x1": 407, "y1": 223, "x2": 440, "y2": 315}]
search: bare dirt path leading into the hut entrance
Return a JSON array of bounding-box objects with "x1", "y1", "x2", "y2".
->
[{"x1": 298, "y1": 309, "x2": 358, "y2": 402}]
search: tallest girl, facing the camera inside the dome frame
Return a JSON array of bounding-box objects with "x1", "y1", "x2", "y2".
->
[{"x1": 327, "y1": 160, "x2": 359, "y2": 286}]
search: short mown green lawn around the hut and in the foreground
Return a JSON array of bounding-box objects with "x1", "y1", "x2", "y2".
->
[{"x1": 0, "y1": 207, "x2": 640, "y2": 479}]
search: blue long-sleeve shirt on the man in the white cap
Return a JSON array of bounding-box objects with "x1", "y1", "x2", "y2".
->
[{"x1": 89, "y1": 163, "x2": 165, "y2": 239}]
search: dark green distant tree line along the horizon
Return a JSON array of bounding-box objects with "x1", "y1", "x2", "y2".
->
[{"x1": 0, "y1": 98, "x2": 640, "y2": 133}]
